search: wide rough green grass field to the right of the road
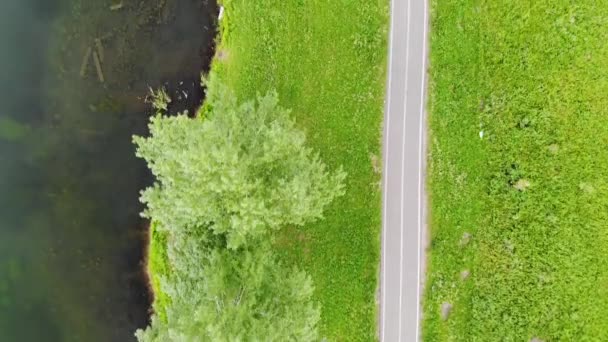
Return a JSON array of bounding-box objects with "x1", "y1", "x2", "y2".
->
[{"x1": 423, "y1": 0, "x2": 608, "y2": 341}]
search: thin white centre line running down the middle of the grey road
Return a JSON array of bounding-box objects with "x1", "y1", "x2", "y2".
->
[{"x1": 399, "y1": 0, "x2": 411, "y2": 341}]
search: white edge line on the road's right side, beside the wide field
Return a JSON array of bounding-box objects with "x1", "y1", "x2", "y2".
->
[{"x1": 416, "y1": 0, "x2": 428, "y2": 341}]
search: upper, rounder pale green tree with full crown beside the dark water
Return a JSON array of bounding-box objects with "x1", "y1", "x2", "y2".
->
[{"x1": 134, "y1": 84, "x2": 345, "y2": 249}]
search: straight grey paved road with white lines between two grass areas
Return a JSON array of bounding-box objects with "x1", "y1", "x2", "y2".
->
[{"x1": 380, "y1": 0, "x2": 428, "y2": 342}]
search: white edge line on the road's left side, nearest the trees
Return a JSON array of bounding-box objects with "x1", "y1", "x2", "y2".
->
[{"x1": 380, "y1": 0, "x2": 397, "y2": 341}]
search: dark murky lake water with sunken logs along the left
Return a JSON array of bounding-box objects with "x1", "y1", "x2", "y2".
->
[{"x1": 0, "y1": 0, "x2": 217, "y2": 342}]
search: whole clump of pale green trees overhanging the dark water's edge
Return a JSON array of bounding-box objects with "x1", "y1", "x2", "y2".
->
[{"x1": 134, "y1": 84, "x2": 346, "y2": 342}]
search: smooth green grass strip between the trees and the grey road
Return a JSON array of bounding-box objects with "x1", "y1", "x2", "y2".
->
[{"x1": 212, "y1": 0, "x2": 389, "y2": 341}]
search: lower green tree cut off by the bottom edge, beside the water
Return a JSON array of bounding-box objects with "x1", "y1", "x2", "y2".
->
[{"x1": 136, "y1": 242, "x2": 319, "y2": 341}]
